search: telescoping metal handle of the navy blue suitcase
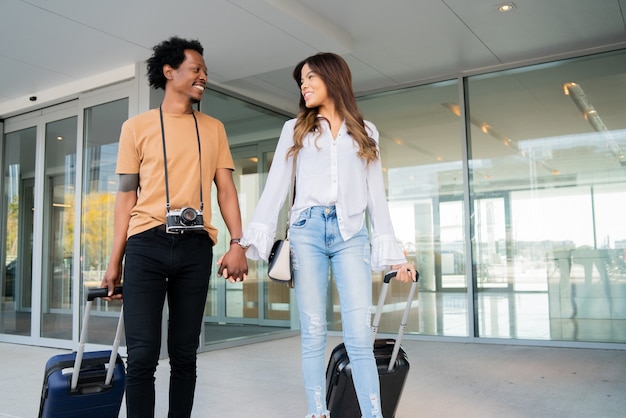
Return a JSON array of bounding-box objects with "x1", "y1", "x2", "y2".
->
[{"x1": 70, "y1": 286, "x2": 124, "y2": 391}]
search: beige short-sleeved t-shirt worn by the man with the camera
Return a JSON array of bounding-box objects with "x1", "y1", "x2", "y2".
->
[{"x1": 116, "y1": 109, "x2": 235, "y2": 243}]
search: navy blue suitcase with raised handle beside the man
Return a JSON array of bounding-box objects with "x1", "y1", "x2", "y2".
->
[{"x1": 39, "y1": 287, "x2": 126, "y2": 418}]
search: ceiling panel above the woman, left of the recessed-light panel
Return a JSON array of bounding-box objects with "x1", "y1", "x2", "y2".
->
[{"x1": 298, "y1": 0, "x2": 499, "y2": 84}]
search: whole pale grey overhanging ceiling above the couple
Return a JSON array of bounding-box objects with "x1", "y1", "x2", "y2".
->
[{"x1": 0, "y1": 0, "x2": 626, "y2": 118}]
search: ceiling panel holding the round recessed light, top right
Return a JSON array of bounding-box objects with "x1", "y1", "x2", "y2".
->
[{"x1": 445, "y1": 0, "x2": 626, "y2": 63}]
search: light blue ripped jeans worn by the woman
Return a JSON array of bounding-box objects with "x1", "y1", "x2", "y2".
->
[{"x1": 289, "y1": 206, "x2": 382, "y2": 418}]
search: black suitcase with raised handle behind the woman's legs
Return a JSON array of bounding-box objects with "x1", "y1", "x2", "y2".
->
[{"x1": 326, "y1": 271, "x2": 419, "y2": 418}]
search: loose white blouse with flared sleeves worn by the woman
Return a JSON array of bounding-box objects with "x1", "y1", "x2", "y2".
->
[{"x1": 242, "y1": 119, "x2": 406, "y2": 271}]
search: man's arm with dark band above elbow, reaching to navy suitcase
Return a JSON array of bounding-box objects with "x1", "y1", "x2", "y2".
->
[{"x1": 102, "y1": 174, "x2": 139, "y2": 299}]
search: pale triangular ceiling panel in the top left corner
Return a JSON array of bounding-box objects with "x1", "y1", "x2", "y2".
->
[{"x1": 0, "y1": 1, "x2": 145, "y2": 93}]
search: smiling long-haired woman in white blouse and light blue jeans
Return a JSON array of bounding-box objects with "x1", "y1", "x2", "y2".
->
[{"x1": 242, "y1": 53, "x2": 415, "y2": 418}]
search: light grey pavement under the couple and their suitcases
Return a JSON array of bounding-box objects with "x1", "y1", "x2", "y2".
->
[{"x1": 0, "y1": 336, "x2": 626, "y2": 418}]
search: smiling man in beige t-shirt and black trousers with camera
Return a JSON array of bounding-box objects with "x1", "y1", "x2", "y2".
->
[{"x1": 102, "y1": 37, "x2": 248, "y2": 418}]
